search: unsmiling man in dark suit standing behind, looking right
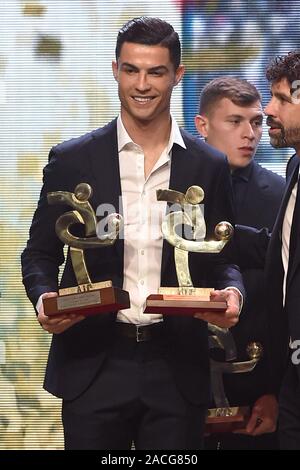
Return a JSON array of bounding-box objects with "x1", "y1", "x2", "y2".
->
[{"x1": 195, "y1": 76, "x2": 284, "y2": 449}]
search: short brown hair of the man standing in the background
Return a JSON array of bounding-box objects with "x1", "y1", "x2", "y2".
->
[{"x1": 199, "y1": 76, "x2": 261, "y2": 114}]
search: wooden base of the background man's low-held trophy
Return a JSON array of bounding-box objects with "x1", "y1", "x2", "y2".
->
[{"x1": 205, "y1": 406, "x2": 250, "y2": 434}]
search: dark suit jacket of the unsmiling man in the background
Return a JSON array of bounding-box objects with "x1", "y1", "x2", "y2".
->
[{"x1": 224, "y1": 162, "x2": 285, "y2": 405}]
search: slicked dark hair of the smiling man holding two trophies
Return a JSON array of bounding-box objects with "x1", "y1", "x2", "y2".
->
[{"x1": 116, "y1": 16, "x2": 181, "y2": 70}]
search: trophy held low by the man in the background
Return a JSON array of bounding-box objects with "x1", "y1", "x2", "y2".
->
[{"x1": 206, "y1": 338, "x2": 263, "y2": 434}]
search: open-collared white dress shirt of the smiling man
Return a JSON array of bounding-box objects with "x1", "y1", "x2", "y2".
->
[{"x1": 117, "y1": 116, "x2": 186, "y2": 325}]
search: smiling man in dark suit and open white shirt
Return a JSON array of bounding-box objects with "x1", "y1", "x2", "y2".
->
[{"x1": 22, "y1": 17, "x2": 243, "y2": 449}]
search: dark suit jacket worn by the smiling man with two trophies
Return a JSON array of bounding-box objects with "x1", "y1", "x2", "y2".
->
[{"x1": 22, "y1": 120, "x2": 243, "y2": 403}]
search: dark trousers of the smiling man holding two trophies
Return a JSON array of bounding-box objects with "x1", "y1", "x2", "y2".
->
[{"x1": 62, "y1": 336, "x2": 206, "y2": 450}]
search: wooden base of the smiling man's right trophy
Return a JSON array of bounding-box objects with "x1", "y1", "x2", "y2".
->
[{"x1": 144, "y1": 287, "x2": 227, "y2": 315}]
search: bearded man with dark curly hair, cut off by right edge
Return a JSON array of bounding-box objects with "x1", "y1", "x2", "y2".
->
[{"x1": 265, "y1": 51, "x2": 300, "y2": 450}]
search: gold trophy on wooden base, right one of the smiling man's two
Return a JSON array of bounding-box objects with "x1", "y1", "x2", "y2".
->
[{"x1": 144, "y1": 186, "x2": 233, "y2": 316}]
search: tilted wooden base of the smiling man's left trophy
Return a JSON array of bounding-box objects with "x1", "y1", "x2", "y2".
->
[{"x1": 43, "y1": 281, "x2": 130, "y2": 316}]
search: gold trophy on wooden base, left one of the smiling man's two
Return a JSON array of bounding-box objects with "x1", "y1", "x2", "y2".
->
[{"x1": 43, "y1": 183, "x2": 130, "y2": 315}]
